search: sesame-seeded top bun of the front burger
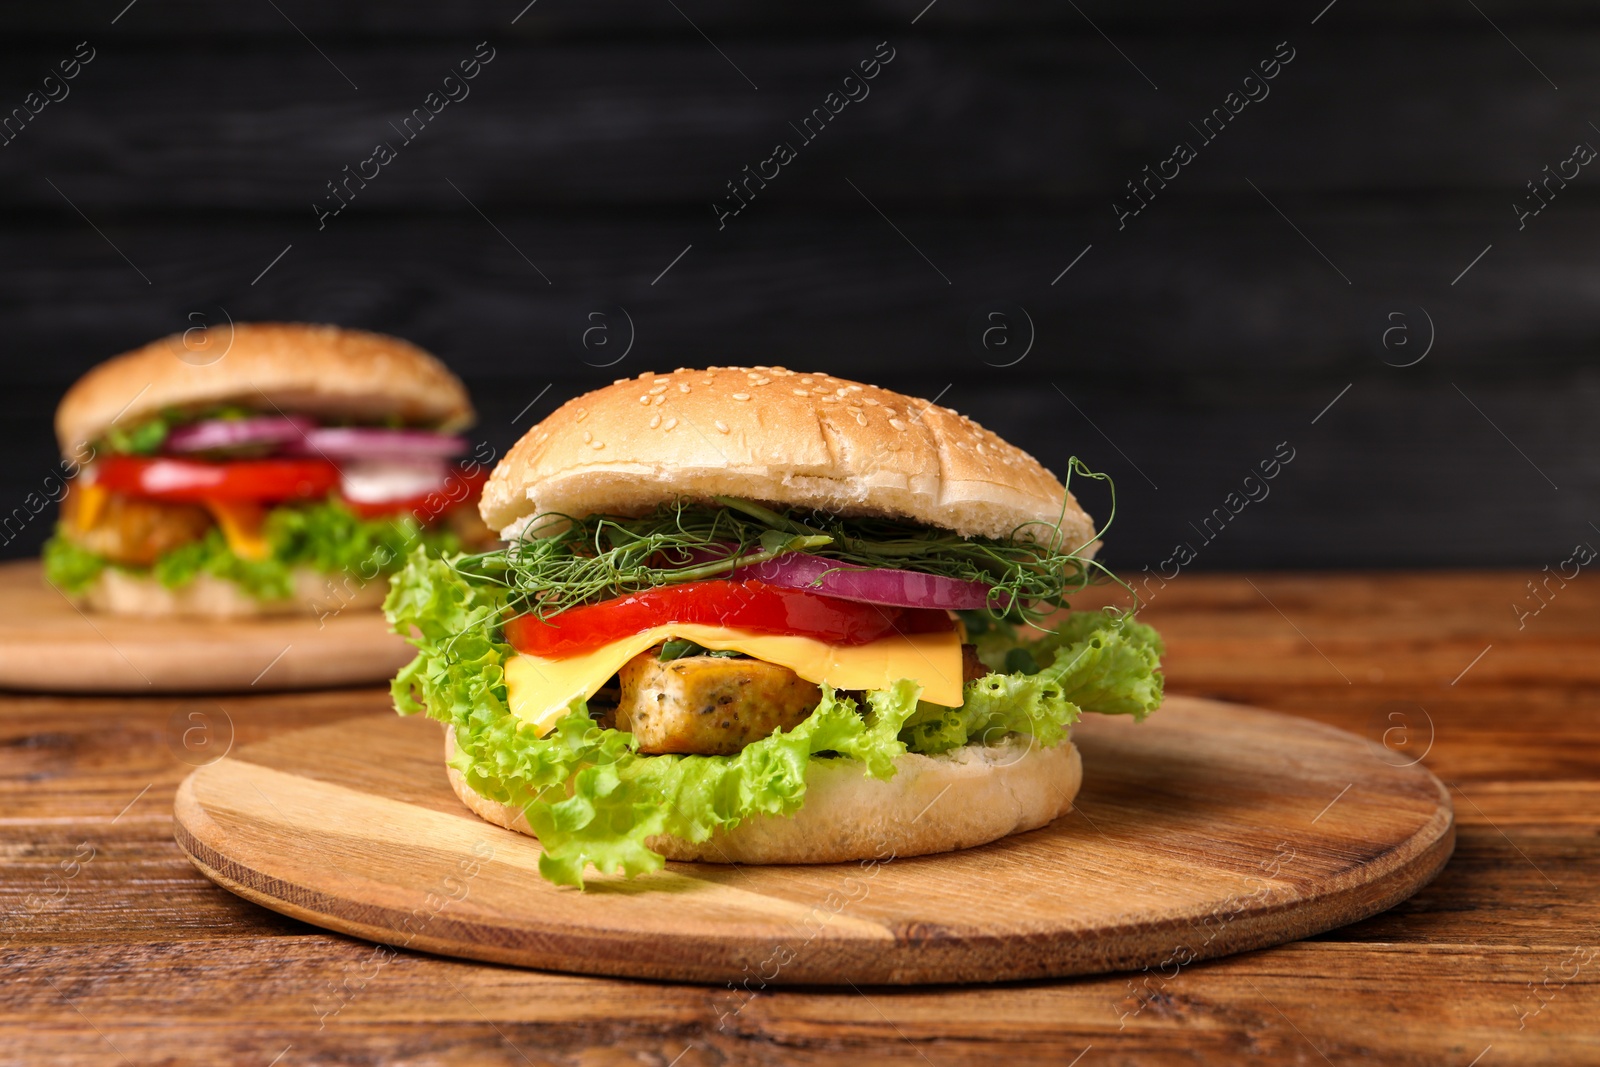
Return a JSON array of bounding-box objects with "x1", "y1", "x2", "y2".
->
[{"x1": 480, "y1": 366, "x2": 1094, "y2": 555}]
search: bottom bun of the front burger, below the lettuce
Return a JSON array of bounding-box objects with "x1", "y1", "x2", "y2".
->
[{"x1": 445, "y1": 729, "x2": 1083, "y2": 864}]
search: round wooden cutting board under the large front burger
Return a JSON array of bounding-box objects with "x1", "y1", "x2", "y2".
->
[{"x1": 176, "y1": 697, "x2": 1454, "y2": 997}]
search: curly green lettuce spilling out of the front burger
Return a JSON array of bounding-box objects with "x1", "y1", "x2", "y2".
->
[{"x1": 384, "y1": 550, "x2": 1162, "y2": 888}]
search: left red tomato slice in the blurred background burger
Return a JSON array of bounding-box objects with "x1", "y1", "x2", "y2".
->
[{"x1": 94, "y1": 456, "x2": 339, "y2": 504}]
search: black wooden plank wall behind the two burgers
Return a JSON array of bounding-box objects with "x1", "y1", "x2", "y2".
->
[{"x1": 0, "y1": 0, "x2": 1600, "y2": 571}]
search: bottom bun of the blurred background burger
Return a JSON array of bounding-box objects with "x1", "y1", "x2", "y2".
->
[{"x1": 72, "y1": 566, "x2": 389, "y2": 619}]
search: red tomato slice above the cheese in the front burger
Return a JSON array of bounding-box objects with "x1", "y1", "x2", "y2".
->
[{"x1": 506, "y1": 579, "x2": 955, "y2": 659}]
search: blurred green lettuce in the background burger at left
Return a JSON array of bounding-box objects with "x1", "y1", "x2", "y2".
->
[{"x1": 43, "y1": 499, "x2": 461, "y2": 600}]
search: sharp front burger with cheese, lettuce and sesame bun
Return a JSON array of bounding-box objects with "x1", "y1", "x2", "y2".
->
[{"x1": 384, "y1": 366, "x2": 1162, "y2": 885}]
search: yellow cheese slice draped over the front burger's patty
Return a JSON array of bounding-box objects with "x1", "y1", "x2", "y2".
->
[{"x1": 506, "y1": 622, "x2": 965, "y2": 736}]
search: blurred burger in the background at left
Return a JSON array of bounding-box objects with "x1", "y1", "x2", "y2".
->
[{"x1": 43, "y1": 323, "x2": 494, "y2": 617}]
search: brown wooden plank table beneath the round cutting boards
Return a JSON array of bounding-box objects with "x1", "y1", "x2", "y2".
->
[{"x1": 0, "y1": 571, "x2": 1600, "y2": 1067}]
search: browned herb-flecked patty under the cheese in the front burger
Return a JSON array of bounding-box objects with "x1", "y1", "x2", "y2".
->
[{"x1": 616, "y1": 646, "x2": 822, "y2": 755}]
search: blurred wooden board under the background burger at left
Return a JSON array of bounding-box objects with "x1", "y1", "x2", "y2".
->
[{"x1": 0, "y1": 560, "x2": 411, "y2": 694}]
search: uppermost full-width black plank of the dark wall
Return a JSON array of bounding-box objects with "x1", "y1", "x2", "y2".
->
[{"x1": 9, "y1": 36, "x2": 1600, "y2": 206}]
